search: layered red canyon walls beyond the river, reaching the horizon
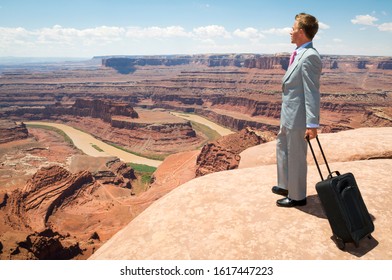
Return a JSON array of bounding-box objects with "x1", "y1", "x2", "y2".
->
[{"x1": 0, "y1": 53, "x2": 392, "y2": 153}]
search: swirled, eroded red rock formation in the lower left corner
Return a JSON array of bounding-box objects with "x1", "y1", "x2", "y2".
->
[{"x1": 0, "y1": 156, "x2": 136, "y2": 259}]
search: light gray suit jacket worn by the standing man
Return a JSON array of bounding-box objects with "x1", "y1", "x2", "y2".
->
[{"x1": 280, "y1": 43, "x2": 322, "y2": 129}]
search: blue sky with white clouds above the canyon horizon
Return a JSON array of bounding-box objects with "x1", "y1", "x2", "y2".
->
[{"x1": 0, "y1": 0, "x2": 392, "y2": 57}]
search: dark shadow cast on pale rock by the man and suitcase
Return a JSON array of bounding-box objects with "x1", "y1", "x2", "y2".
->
[{"x1": 296, "y1": 194, "x2": 379, "y2": 257}]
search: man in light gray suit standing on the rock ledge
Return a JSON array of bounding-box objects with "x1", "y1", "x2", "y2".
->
[{"x1": 272, "y1": 13, "x2": 322, "y2": 207}]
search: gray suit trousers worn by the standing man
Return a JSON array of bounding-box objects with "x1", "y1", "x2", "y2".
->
[{"x1": 276, "y1": 126, "x2": 308, "y2": 200}]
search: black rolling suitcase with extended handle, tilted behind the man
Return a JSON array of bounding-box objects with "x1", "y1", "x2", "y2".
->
[{"x1": 308, "y1": 137, "x2": 374, "y2": 250}]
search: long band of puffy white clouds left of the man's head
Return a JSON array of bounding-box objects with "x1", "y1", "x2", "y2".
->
[{"x1": 0, "y1": 25, "x2": 304, "y2": 46}]
